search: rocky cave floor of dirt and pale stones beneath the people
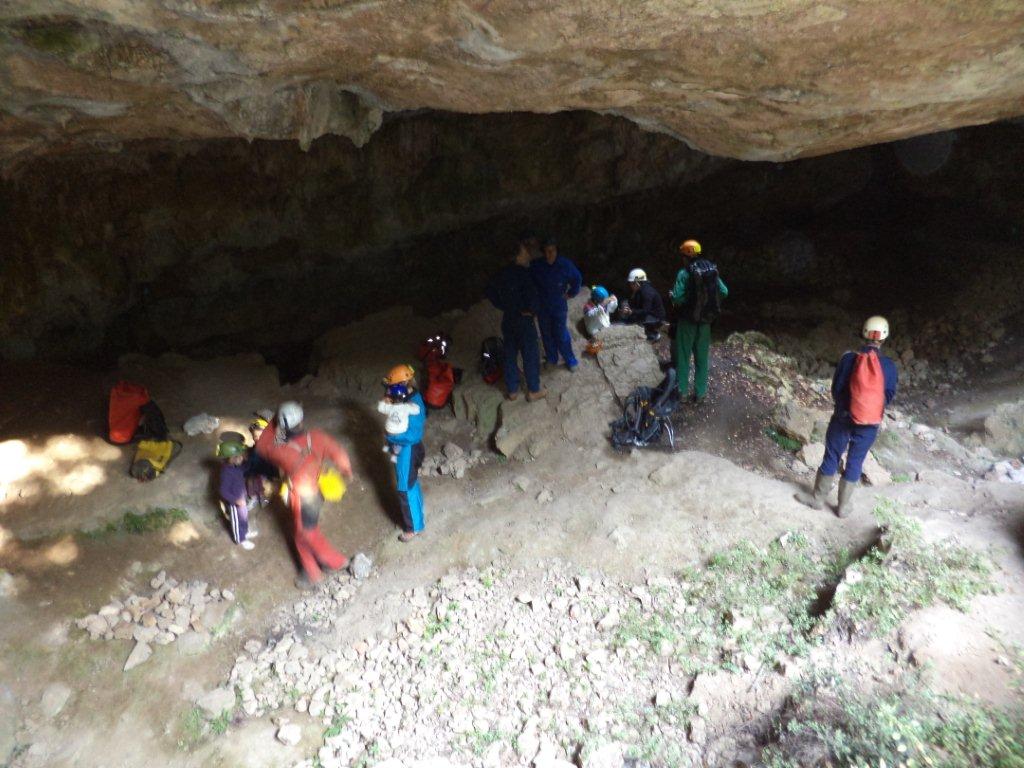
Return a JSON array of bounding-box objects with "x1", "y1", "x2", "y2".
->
[{"x1": 0, "y1": 296, "x2": 1024, "y2": 768}]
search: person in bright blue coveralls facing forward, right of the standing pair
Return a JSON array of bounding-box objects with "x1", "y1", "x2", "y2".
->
[{"x1": 529, "y1": 238, "x2": 583, "y2": 371}]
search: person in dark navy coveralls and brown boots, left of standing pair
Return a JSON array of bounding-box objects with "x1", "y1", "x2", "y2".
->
[{"x1": 485, "y1": 243, "x2": 548, "y2": 402}]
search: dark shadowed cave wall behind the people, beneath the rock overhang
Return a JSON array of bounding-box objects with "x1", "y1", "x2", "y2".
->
[{"x1": 0, "y1": 113, "x2": 1024, "y2": 368}]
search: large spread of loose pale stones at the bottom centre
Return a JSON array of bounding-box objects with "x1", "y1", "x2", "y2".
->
[{"x1": 230, "y1": 563, "x2": 778, "y2": 768}]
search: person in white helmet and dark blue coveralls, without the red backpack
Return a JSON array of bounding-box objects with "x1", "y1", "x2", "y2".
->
[{"x1": 797, "y1": 316, "x2": 898, "y2": 517}]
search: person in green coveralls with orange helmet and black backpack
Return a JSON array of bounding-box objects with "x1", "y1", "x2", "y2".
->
[{"x1": 671, "y1": 240, "x2": 729, "y2": 404}]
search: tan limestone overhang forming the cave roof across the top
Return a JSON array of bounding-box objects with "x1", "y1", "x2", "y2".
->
[{"x1": 0, "y1": 0, "x2": 1024, "y2": 160}]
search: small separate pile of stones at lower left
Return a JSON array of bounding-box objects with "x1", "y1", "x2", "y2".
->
[{"x1": 76, "y1": 570, "x2": 234, "y2": 672}]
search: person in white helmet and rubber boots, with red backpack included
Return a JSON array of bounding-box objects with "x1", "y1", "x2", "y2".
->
[{"x1": 796, "y1": 315, "x2": 898, "y2": 517}]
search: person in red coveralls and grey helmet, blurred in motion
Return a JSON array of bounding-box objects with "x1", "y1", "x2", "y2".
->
[{"x1": 256, "y1": 401, "x2": 352, "y2": 590}]
